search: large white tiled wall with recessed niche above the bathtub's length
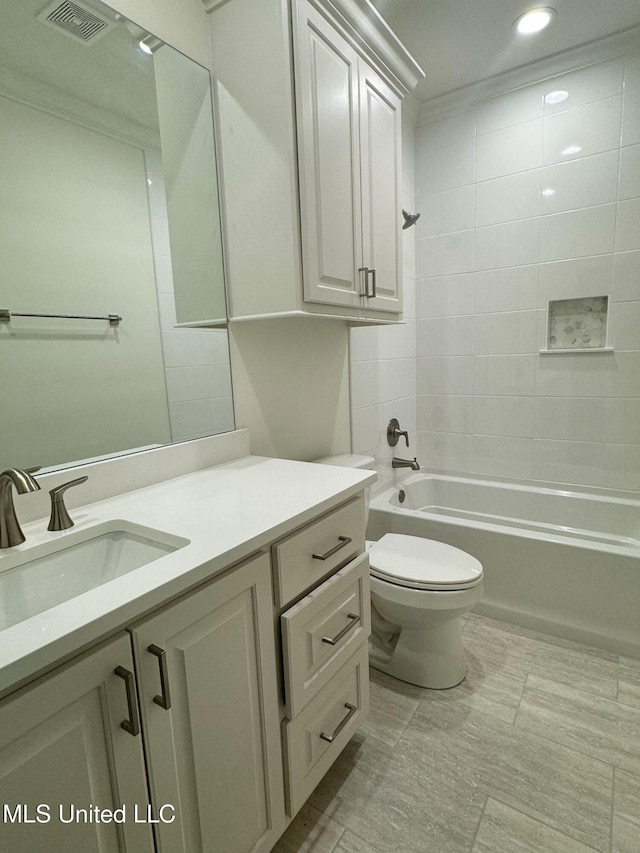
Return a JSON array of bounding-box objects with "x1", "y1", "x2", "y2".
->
[{"x1": 417, "y1": 50, "x2": 640, "y2": 490}]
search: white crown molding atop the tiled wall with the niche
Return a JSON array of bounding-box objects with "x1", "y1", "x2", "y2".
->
[{"x1": 417, "y1": 27, "x2": 640, "y2": 127}]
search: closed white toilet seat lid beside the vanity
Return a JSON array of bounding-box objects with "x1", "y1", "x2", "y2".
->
[{"x1": 369, "y1": 533, "x2": 482, "y2": 589}]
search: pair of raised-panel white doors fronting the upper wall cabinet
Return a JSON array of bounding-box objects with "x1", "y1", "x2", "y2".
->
[{"x1": 294, "y1": 2, "x2": 402, "y2": 313}]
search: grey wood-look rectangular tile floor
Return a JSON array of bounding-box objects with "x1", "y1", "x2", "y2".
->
[{"x1": 274, "y1": 614, "x2": 640, "y2": 853}]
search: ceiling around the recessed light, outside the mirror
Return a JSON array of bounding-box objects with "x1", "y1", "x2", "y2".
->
[{"x1": 371, "y1": 0, "x2": 640, "y2": 101}]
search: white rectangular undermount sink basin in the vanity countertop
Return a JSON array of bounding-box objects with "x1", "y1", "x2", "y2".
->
[{"x1": 0, "y1": 521, "x2": 189, "y2": 630}]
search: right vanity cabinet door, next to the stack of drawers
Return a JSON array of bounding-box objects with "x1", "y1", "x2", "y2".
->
[{"x1": 132, "y1": 554, "x2": 284, "y2": 853}]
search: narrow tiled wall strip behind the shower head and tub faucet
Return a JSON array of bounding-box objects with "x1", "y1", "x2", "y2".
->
[{"x1": 350, "y1": 103, "x2": 418, "y2": 489}]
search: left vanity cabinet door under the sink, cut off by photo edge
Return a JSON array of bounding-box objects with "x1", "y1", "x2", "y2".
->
[{"x1": 0, "y1": 634, "x2": 154, "y2": 853}]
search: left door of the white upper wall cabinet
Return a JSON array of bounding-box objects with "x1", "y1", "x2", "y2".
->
[{"x1": 296, "y1": 3, "x2": 362, "y2": 307}]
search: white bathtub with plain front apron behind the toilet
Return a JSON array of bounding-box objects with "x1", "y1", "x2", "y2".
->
[{"x1": 367, "y1": 473, "x2": 640, "y2": 658}]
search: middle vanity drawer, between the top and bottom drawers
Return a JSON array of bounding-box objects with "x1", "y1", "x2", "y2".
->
[{"x1": 280, "y1": 554, "x2": 371, "y2": 719}]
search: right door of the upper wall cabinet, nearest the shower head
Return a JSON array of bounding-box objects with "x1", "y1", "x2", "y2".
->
[{"x1": 359, "y1": 59, "x2": 402, "y2": 312}]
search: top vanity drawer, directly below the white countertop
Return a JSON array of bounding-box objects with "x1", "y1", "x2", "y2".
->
[{"x1": 272, "y1": 496, "x2": 365, "y2": 607}]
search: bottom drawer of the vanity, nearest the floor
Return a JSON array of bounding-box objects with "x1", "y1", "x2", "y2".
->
[{"x1": 283, "y1": 643, "x2": 369, "y2": 817}]
